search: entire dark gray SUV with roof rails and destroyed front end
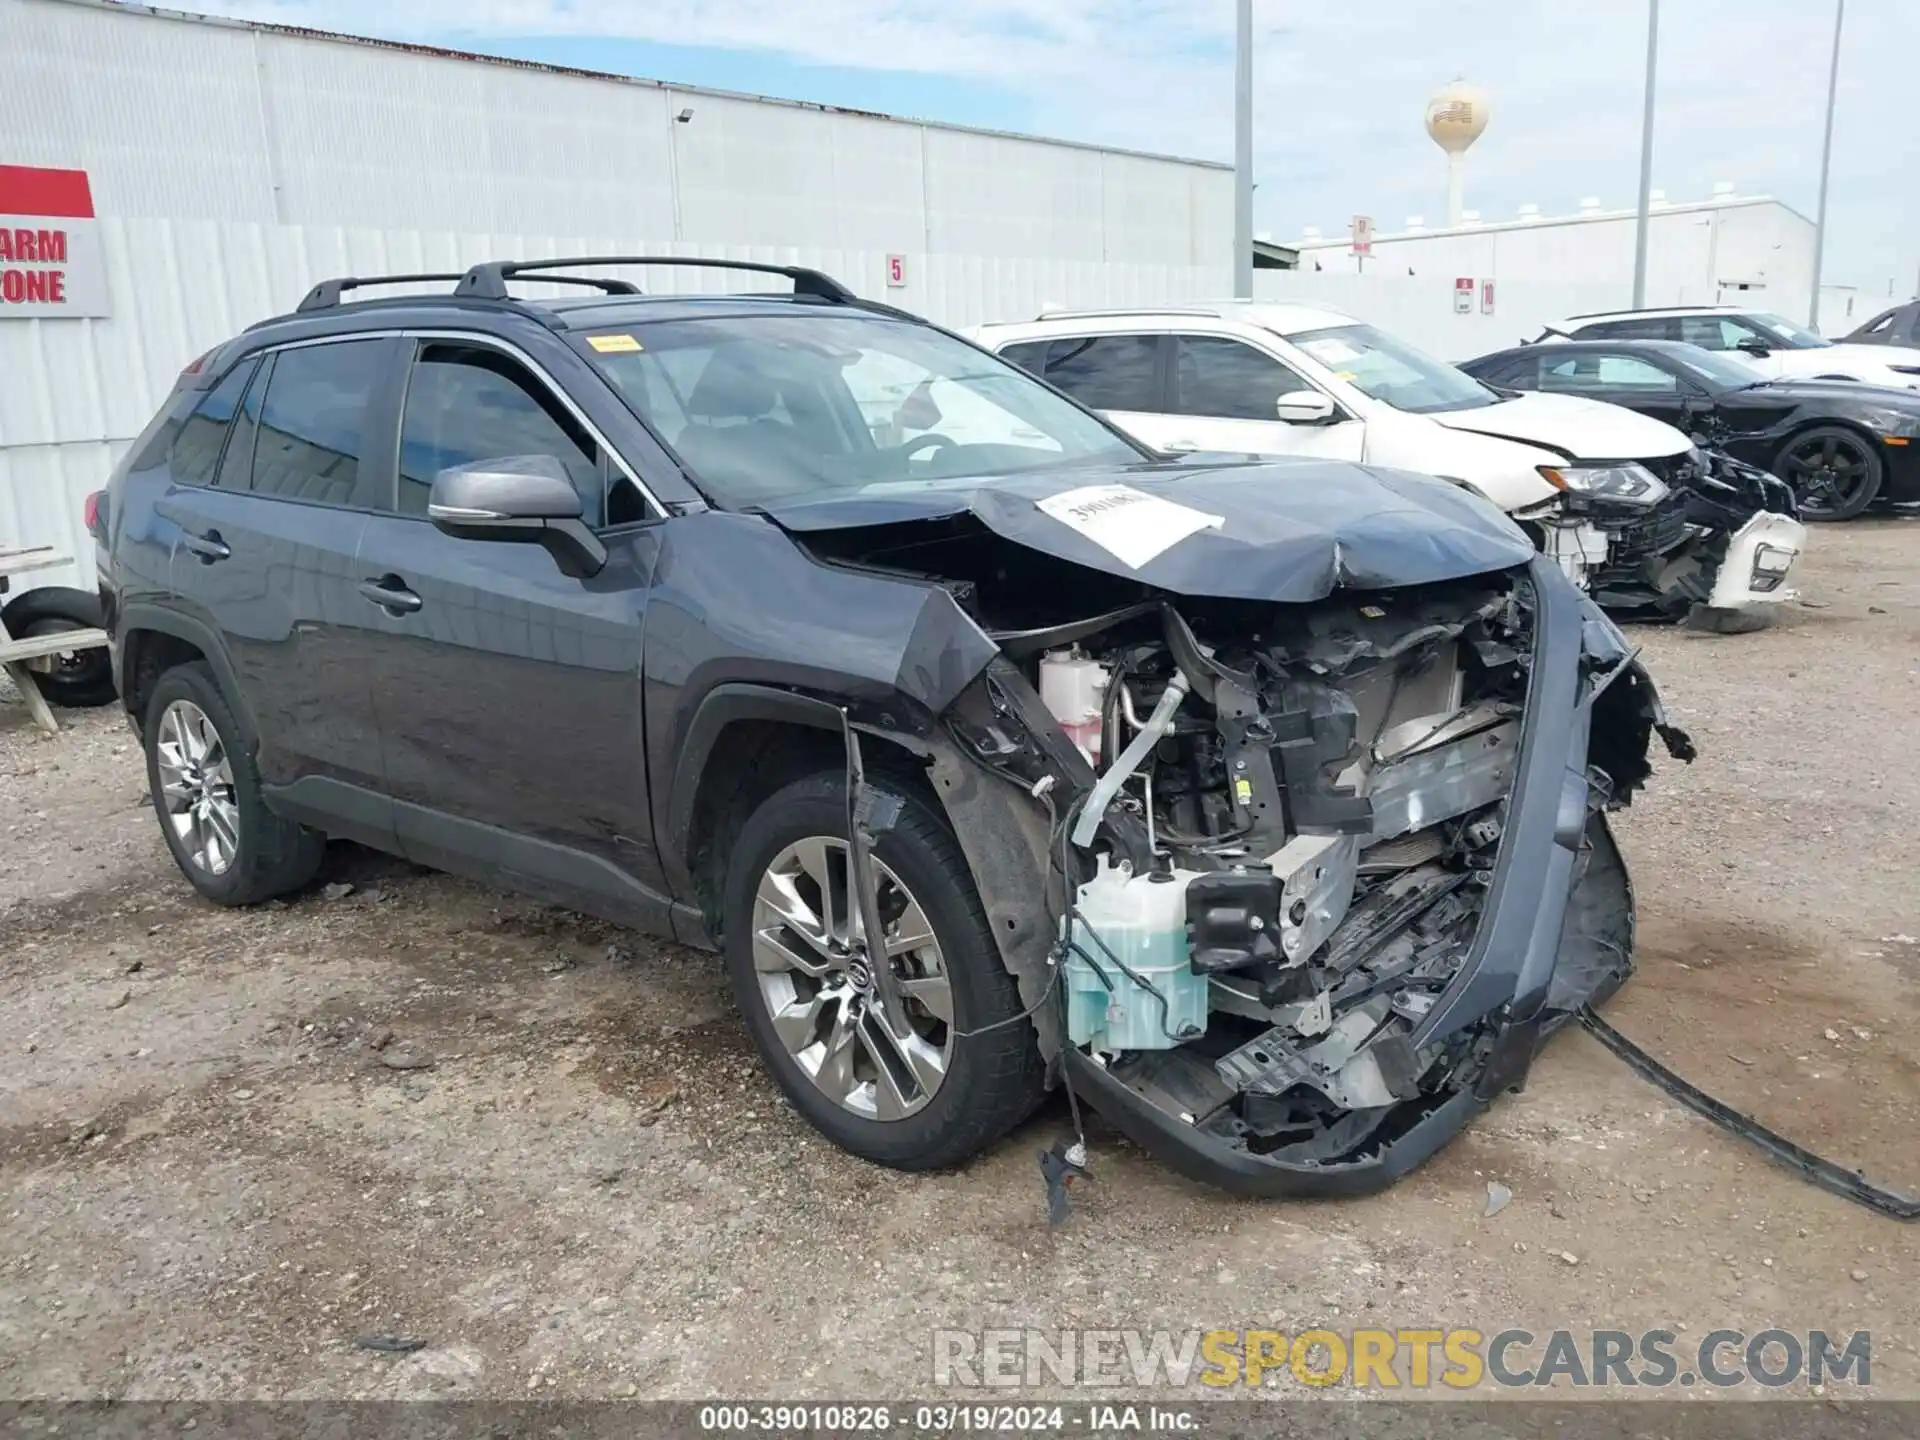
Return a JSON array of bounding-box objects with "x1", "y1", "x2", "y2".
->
[{"x1": 96, "y1": 257, "x2": 1690, "y2": 1194}]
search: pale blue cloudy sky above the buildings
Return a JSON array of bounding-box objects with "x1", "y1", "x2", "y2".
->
[{"x1": 186, "y1": 0, "x2": 1920, "y2": 296}]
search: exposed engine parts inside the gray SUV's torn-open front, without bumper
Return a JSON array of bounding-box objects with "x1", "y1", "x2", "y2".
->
[{"x1": 1035, "y1": 584, "x2": 1582, "y2": 1160}]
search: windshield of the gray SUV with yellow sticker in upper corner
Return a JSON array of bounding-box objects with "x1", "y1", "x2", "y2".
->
[{"x1": 582, "y1": 311, "x2": 1144, "y2": 509}]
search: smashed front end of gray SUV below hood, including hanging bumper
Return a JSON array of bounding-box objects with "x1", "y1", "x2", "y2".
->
[{"x1": 779, "y1": 462, "x2": 1692, "y2": 1194}]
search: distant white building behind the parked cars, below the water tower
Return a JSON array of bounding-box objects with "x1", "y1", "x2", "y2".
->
[{"x1": 1298, "y1": 186, "x2": 1814, "y2": 319}]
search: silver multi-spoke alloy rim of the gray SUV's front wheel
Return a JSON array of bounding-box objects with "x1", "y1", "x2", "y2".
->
[{"x1": 753, "y1": 835, "x2": 954, "y2": 1119}]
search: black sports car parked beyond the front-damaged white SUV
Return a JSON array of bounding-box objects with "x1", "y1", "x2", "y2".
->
[{"x1": 1459, "y1": 340, "x2": 1920, "y2": 520}]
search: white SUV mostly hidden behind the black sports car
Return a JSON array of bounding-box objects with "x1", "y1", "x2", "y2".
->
[{"x1": 1540, "y1": 305, "x2": 1920, "y2": 390}]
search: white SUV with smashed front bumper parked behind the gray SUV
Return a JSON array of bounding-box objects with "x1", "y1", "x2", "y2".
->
[{"x1": 973, "y1": 301, "x2": 1807, "y2": 628}]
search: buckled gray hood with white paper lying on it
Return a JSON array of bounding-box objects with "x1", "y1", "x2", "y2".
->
[{"x1": 764, "y1": 458, "x2": 1536, "y2": 603}]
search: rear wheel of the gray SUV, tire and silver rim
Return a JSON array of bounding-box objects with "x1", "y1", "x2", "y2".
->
[{"x1": 142, "y1": 660, "x2": 326, "y2": 906}]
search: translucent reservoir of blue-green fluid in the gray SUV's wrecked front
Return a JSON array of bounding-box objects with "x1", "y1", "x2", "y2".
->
[{"x1": 1064, "y1": 854, "x2": 1208, "y2": 1050}]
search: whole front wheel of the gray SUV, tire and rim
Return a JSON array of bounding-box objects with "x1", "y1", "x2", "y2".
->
[{"x1": 724, "y1": 772, "x2": 1043, "y2": 1169}]
